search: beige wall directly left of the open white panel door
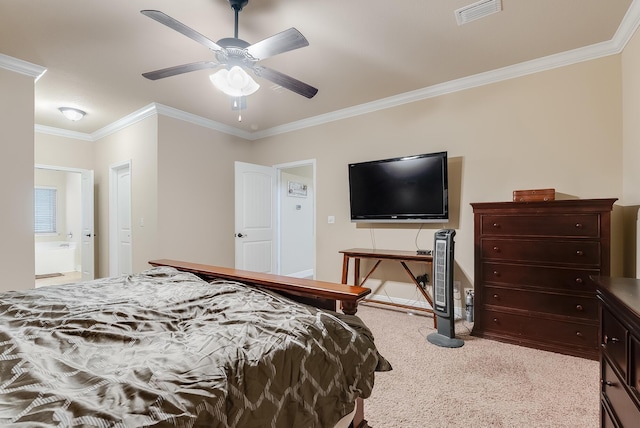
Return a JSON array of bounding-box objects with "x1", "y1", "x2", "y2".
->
[{"x1": 156, "y1": 116, "x2": 252, "y2": 267}]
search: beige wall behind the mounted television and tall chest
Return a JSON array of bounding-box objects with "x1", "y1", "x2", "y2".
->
[{"x1": 253, "y1": 56, "x2": 622, "y2": 304}]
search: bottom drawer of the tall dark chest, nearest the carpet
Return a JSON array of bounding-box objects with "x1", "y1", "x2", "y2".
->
[{"x1": 479, "y1": 306, "x2": 598, "y2": 351}]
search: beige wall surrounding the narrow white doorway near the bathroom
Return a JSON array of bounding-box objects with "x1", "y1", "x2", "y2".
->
[{"x1": 93, "y1": 116, "x2": 159, "y2": 277}]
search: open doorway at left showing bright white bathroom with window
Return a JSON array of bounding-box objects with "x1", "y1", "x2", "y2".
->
[{"x1": 34, "y1": 165, "x2": 95, "y2": 287}]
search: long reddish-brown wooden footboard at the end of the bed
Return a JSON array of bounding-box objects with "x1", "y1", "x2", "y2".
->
[{"x1": 149, "y1": 259, "x2": 371, "y2": 428}]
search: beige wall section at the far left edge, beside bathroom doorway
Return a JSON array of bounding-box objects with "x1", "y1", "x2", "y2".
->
[{"x1": 0, "y1": 67, "x2": 35, "y2": 291}]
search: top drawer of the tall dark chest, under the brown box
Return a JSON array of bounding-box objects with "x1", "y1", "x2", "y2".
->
[{"x1": 481, "y1": 214, "x2": 600, "y2": 238}]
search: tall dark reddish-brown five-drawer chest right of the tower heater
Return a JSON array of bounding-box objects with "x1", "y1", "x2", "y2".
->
[{"x1": 471, "y1": 199, "x2": 616, "y2": 360}]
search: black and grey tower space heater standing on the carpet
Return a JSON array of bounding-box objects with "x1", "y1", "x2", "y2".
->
[{"x1": 427, "y1": 229, "x2": 464, "y2": 348}]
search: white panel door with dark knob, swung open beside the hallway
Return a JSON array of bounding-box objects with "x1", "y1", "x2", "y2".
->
[{"x1": 235, "y1": 162, "x2": 277, "y2": 273}]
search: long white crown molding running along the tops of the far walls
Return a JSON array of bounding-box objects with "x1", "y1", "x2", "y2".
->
[{"x1": 33, "y1": 0, "x2": 640, "y2": 141}]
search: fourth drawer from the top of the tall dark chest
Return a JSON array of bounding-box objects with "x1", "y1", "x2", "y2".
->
[{"x1": 482, "y1": 286, "x2": 598, "y2": 322}]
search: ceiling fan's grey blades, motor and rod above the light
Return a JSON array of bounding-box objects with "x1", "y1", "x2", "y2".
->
[{"x1": 140, "y1": 0, "x2": 318, "y2": 98}]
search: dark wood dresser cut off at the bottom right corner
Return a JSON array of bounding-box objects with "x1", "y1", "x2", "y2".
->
[{"x1": 595, "y1": 277, "x2": 640, "y2": 427}]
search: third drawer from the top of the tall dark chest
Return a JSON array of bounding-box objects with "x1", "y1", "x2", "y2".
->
[{"x1": 482, "y1": 262, "x2": 600, "y2": 293}]
